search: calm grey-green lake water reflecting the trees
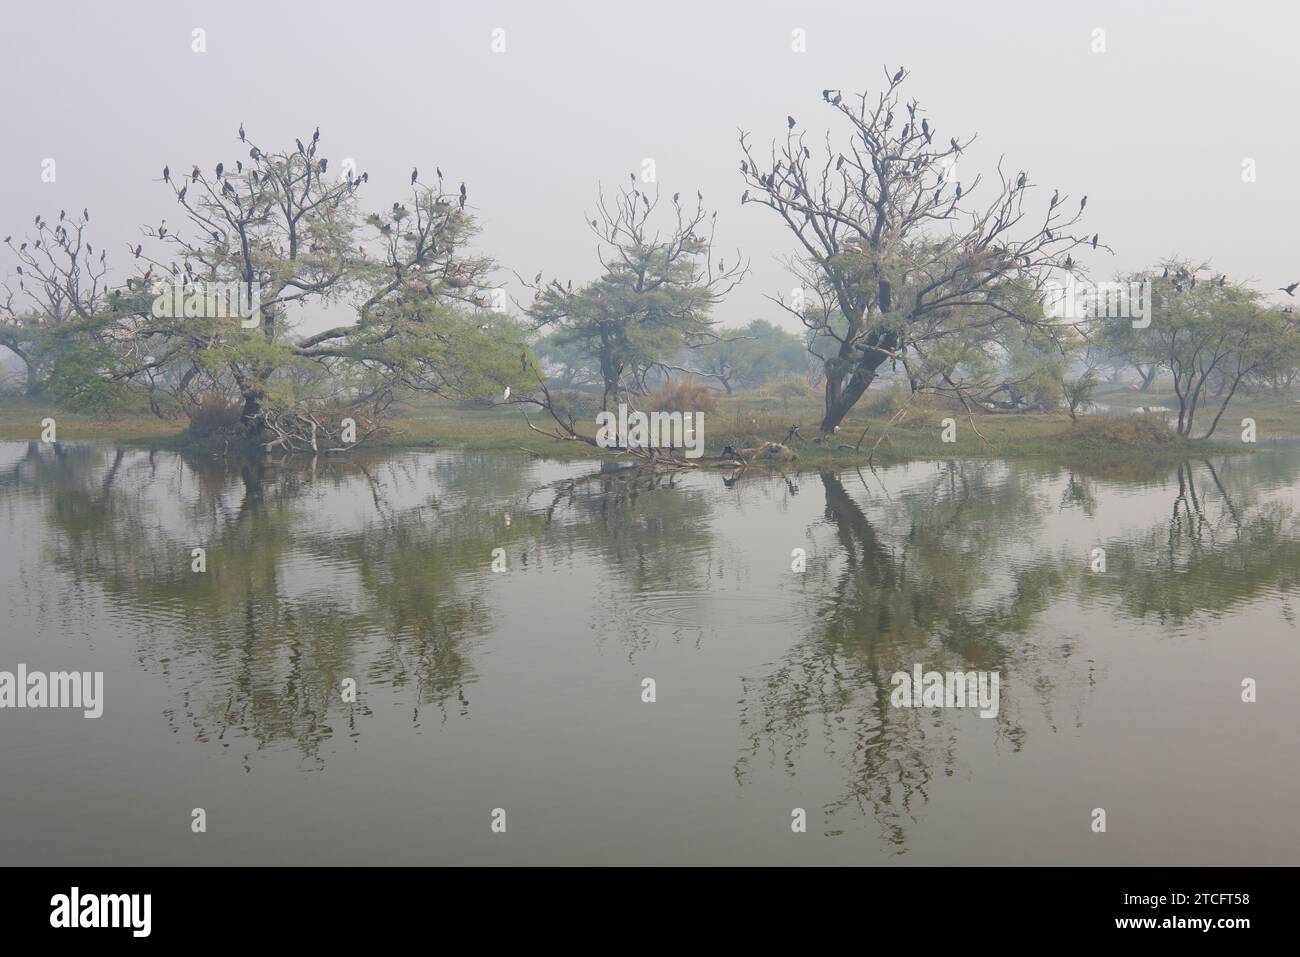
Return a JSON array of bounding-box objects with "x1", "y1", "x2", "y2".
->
[{"x1": 0, "y1": 443, "x2": 1300, "y2": 865}]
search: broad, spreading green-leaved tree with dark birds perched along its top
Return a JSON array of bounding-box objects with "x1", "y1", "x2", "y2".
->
[{"x1": 3, "y1": 127, "x2": 528, "y2": 451}]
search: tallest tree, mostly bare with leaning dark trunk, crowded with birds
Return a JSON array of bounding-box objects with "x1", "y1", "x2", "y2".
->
[{"x1": 740, "y1": 69, "x2": 1097, "y2": 432}]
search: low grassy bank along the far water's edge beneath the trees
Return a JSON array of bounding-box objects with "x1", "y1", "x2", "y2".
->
[{"x1": 0, "y1": 390, "x2": 1300, "y2": 465}]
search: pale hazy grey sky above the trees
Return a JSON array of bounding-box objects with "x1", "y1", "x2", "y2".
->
[{"x1": 0, "y1": 0, "x2": 1300, "y2": 328}]
